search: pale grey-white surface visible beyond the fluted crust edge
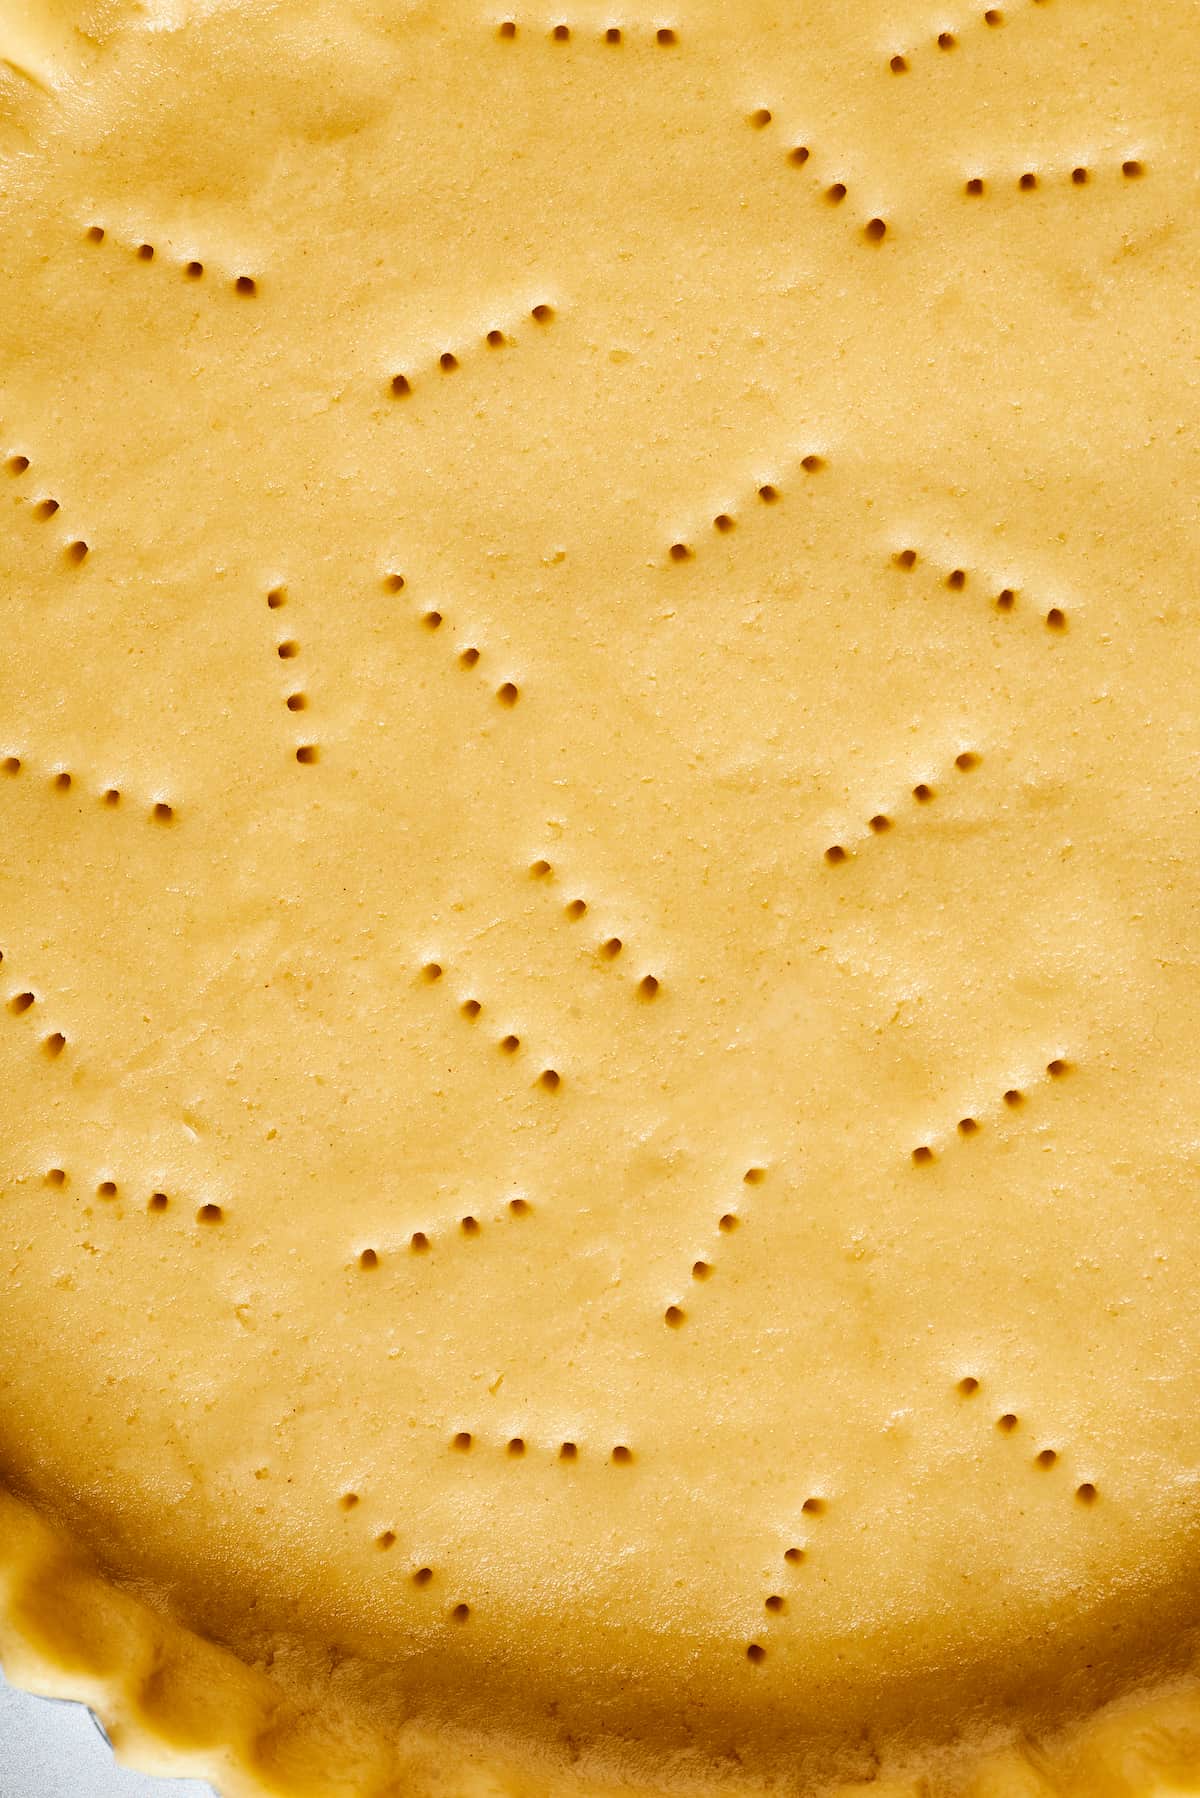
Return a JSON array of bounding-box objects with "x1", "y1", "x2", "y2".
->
[{"x1": 0, "y1": 1674, "x2": 212, "y2": 1798}]
